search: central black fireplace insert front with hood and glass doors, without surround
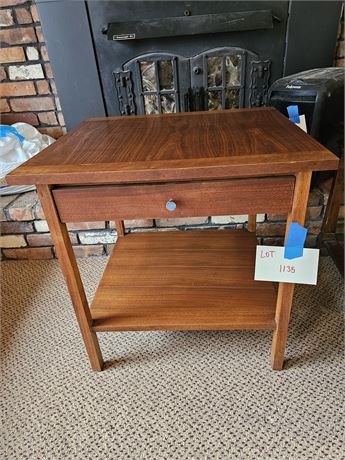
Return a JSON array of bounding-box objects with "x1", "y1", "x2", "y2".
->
[{"x1": 87, "y1": 1, "x2": 288, "y2": 115}]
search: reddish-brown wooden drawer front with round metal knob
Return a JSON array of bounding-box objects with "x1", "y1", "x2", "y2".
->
[{"x1": 53, "y1": 176, "x2": 295, "y2": 222}]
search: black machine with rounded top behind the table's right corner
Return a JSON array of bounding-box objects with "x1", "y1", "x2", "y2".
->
[{"x1": 267, "y1": 67, "x2": 344, "y2": 161}]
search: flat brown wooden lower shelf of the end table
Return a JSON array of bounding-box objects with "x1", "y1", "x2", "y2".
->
[{"x1": 91, "y1": 230, "x2": 276, "y2": 331}]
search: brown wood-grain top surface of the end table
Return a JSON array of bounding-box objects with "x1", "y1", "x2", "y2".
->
[{"x1": 7, "y1": 107, "x2": 338, "y2": 184}]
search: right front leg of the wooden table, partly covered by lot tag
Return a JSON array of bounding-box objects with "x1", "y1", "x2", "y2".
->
[{"x1": 272, "y1": 171, "x2": 312, "y2": 370}]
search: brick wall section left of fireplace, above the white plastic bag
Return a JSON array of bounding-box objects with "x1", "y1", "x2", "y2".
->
[{"x1": 0, "y1": 0, "x2": 65, "y2": 138}]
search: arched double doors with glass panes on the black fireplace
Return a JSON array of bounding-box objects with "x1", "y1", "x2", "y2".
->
[{"x1": 114, "y1": 48, "x2": 269, "y2": 115}]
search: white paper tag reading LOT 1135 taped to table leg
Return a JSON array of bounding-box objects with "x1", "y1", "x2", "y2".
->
[{"x1": 254, "y1": 246, "x2": 319, "y2": 284}]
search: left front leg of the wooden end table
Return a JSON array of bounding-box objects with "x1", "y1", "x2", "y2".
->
[{"x1": 37, "y1": 185, "x2": 103, "y2": 371}]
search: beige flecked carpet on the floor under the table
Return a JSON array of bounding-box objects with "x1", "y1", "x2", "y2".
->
[{"x1": 0, "y1": 258, "x2": 345, "y2": 460}]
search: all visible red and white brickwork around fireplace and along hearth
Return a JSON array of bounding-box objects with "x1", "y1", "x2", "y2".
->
[{"x1": 0, "y1": 0, "x2": 345, "y2": 259}]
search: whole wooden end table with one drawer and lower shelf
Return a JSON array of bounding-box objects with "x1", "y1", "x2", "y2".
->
[{"x1": 7, "y1": 108, "x2": 338, "y2": 371}]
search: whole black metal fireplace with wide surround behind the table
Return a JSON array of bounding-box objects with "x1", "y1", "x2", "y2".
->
[{"x1": 38, "y1": 0, "x2": 341, "y2": 128}]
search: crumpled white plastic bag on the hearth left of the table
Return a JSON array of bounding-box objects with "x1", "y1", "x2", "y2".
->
[{"x1": 0, "y1": 123, "x2": 55, "y2": 195}]
